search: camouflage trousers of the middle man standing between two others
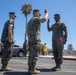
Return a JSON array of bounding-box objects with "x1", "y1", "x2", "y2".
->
[{"x1": 28, "y1": 42, "x2": 39, "y2": 66}]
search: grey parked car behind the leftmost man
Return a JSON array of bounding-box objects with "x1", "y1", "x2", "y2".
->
[{"x1": 0, "y1": 45, "x2": 24, "y2": 57}]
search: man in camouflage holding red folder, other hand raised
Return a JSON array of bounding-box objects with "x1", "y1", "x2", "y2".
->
[{"x1": 47, "y1": 14, "x2": 67, "y2": 70}]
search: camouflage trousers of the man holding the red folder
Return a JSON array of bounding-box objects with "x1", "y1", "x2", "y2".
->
[{"x1": 52, "y1": 41, "x2": 63, "y2": 64}]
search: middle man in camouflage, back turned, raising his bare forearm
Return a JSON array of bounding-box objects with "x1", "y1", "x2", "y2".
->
[{"x1": 26, "y1": 9, "x2": 48, "y2": 74}]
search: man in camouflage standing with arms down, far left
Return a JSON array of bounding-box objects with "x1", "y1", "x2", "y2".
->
[{"x1": 1, "y1": 12, "x2": 16, "y2": 71}]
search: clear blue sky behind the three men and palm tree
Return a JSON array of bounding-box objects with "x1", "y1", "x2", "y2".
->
[{"x1": 0, "y1": 0, "x2": 76, "y2": 50}]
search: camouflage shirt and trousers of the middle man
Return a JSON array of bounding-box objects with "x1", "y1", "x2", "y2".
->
[{"x1": 27, "y1": 17, "x2": 41, "y2": 66}]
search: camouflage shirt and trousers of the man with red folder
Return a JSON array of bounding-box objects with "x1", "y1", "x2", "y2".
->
[{"x1": 51, "y1": 22, "x2": 66, "y2": 64}]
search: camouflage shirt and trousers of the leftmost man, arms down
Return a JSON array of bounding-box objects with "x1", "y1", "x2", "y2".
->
[{"x1": 1, "y1": 19, "x2": 14, "y2": 66}]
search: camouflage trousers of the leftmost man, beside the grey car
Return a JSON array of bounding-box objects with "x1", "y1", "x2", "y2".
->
[{"x1": 1, "y1": 42, "x2": 13, "y2": 66}]
